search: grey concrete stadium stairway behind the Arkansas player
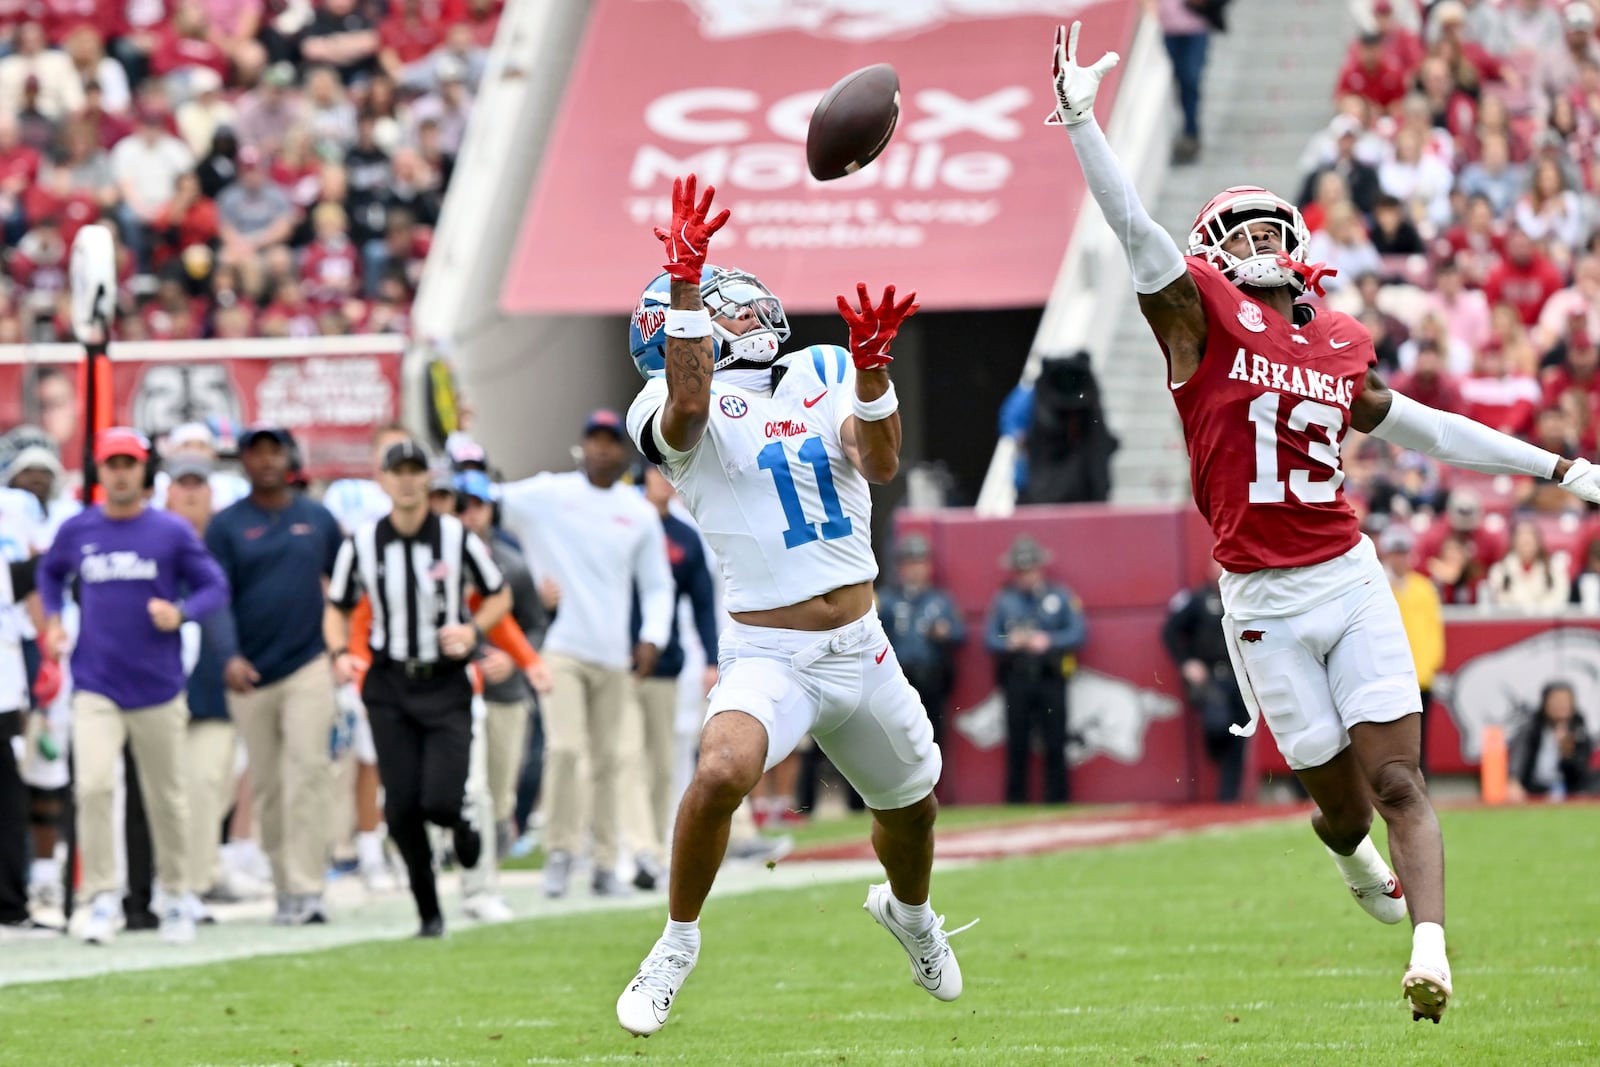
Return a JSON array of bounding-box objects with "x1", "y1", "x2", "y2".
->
[{"x1": 1096, "y1": 0, "x2": 1355, "y2": 504}]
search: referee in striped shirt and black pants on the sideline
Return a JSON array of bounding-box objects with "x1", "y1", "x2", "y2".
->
[{"x1": 325, "y1": 442, "x2": 510, "y2": 937}]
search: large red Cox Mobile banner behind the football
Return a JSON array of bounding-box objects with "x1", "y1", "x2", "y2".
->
[{"x1": 501, "y1": 0, "x2": 1139, "y2": 314}]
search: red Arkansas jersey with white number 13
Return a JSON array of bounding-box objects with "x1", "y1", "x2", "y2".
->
[{"x1": 1173, "y1": 256, "x2": 1378, "y2": 574}]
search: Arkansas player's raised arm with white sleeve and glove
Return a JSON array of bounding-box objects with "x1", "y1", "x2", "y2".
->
[{"x1": 1045, "y1": 22, "x2": 1205, "y2": 381}]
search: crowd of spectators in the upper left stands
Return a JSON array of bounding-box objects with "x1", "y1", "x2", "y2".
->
[{"x1": 0, "y1": 0, "x2": 504, "y2": 344}]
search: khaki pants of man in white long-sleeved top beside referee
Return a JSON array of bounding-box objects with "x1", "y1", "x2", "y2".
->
[{"x1": 544, "y1": 653, "x2": 634, "y2": 870}]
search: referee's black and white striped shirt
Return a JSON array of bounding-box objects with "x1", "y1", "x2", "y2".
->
[{"x1": 328, "y1": 515, "x2": 504, "y2": 662}]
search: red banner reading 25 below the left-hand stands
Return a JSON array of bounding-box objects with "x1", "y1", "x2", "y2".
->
[{"x1": 0, "y1": 336, "x2": 403, "y2": 478}]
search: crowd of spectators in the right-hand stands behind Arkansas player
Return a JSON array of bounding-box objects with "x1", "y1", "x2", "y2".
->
[{"x1": 1301, "y1": 0, "x2": 1600, "y2": 603}]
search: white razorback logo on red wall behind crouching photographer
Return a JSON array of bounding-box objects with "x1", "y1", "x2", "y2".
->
[{"x1": 1434, "y1": 627, "x2": 1600, "y2": 763}]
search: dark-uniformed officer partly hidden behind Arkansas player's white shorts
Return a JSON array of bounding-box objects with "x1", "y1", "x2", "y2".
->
[{"x1": 1162, "y1": 563, "x2": 1250, "y2": 803}]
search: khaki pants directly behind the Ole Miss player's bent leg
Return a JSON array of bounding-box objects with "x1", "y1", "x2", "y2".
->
[{"x1": 618, "y1": 678, "x2": 678, "y2": 862}]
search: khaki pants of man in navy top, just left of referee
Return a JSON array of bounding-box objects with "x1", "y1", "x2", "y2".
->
[{"x1": 227, "y1": 656, "x2": 334, "y2": 894}]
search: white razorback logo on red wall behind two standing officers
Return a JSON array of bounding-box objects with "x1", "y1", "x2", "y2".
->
[{"x1": 955, "y1": 667, "x2": 1182, "y2": 765}]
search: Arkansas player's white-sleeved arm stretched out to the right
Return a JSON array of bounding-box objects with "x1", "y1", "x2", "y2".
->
[{"x1": 1350, "y1": 371, "x2": 1600, "y2": 504}]
